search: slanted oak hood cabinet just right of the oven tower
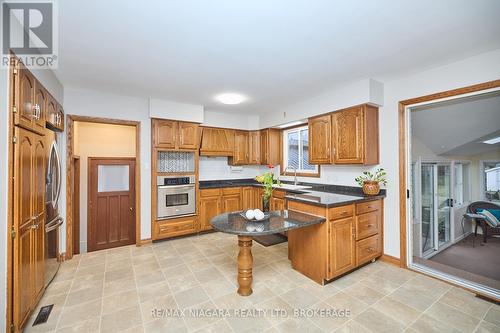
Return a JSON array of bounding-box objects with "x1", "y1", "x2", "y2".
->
[{"x1": 200, "y1": 127, "x2": 234, "y2": 156}]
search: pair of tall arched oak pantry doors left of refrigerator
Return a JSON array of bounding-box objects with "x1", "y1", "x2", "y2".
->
[{"x1": 12, "y1": 126, "x2": 47, "y2": 327}]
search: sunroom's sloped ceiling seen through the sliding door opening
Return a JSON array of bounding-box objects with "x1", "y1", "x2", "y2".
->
[{"x1": 411, "y1": 92, "x2": 500, "y2": 156}]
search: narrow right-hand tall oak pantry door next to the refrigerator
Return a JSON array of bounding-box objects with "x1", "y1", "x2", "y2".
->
[{"x1": 32, "y1": 135, "x2": 47, "y2": 302}]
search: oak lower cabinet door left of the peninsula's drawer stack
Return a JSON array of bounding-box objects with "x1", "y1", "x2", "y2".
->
[{"x1": 328, "y1": 217, "x2": 356, "y2": 278}]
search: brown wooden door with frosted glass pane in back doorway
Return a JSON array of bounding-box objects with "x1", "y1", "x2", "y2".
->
[{"x1": 87, "y1": 157, "x2": 136, "y2": 252}]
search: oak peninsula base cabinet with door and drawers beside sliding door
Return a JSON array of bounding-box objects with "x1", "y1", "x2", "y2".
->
[{"x1": 287, "y1": 199, "x2": 383, "y2": 284}]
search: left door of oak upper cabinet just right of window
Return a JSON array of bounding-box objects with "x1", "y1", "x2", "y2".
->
[{"x1": 309, "y1": 114, "x2": 332, "y2": 164}]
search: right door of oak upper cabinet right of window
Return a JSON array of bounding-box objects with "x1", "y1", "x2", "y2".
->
[{"x1": 333, "y1": 107, "x2": 364, "y2": 164}]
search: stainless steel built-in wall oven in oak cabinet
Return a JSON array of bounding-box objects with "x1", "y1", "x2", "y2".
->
[{"x1": 157, "y1": 175, "x2": 196, "y2": 219}]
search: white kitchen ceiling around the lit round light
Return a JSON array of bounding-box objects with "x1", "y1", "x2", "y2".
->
[{"x1": 56, "y1": 0, "x2": 500, "y2": 113}]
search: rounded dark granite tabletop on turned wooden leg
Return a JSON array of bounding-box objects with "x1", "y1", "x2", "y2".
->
[{"x1": 210, "y1": 210, "x2": 326, "y2": 236}]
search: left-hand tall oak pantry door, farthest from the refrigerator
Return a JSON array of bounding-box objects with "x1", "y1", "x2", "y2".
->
[{"x1": 13, "y1": 126, "x2": 34, "y2": 327}]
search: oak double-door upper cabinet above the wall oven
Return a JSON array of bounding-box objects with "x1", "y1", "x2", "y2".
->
[{"x1": 152, "y1": 119, "x2": 199, "y2": 149}]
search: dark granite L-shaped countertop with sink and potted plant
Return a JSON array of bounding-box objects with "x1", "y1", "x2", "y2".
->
[{"x1": 200, "y1": 178, "x2": 385, "y2": 207}]
